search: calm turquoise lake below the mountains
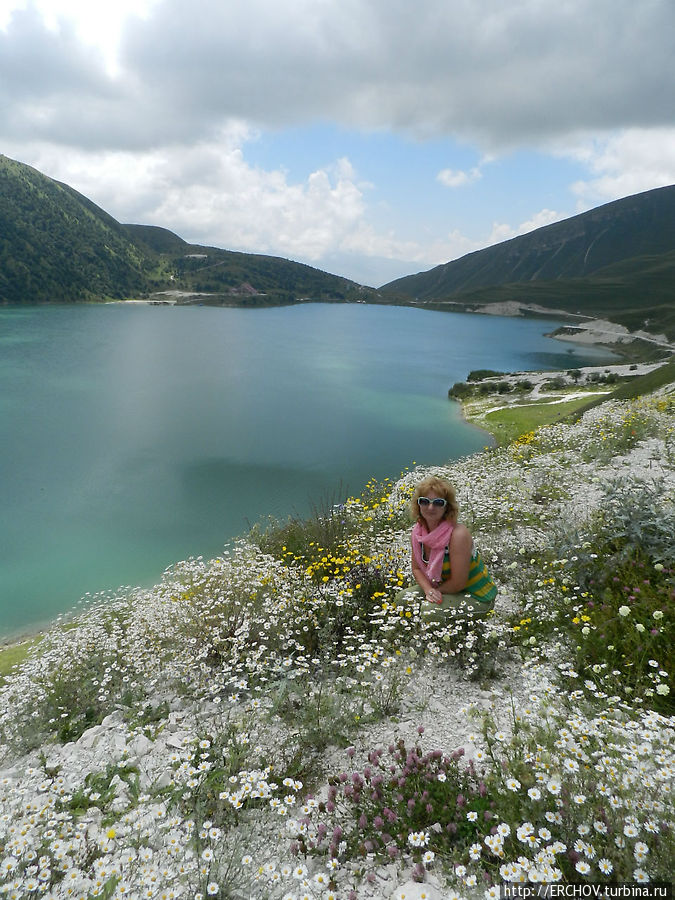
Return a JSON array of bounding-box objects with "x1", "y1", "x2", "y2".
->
[{"x1": 0, "y1": 304, "x2": 610, "y2": 636}]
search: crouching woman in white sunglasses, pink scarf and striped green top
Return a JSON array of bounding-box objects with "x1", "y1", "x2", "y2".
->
[{"x1": 402, "y1": 476, "x2": 497, "y2": 616}]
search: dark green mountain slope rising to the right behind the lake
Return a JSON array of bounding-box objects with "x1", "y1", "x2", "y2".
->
[{"x1": 381, "y1": 185, "x2": 675, "y2": 338}]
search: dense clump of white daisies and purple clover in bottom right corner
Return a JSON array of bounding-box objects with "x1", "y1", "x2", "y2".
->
[{"x1": 295, "y1": 698, "x2": 673, "y2": 884}]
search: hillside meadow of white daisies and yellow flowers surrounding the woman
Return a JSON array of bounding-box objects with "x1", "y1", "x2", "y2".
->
[{"x1": 0, "y1": 389, "x2": 675, "y2": 900}]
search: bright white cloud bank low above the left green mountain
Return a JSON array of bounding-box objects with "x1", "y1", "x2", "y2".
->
[{"x1": 6, "y1": 136, "x2": 365, "y2": 261}]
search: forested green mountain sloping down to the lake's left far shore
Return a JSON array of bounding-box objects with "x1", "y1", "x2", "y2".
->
[{"x1": 0, "y1": 155, "x2": 375, "y2": 306}]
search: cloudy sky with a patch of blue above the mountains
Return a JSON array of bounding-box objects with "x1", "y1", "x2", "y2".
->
[{"x1": 0, "y1": 0, "x2": 675, "y2": 286}]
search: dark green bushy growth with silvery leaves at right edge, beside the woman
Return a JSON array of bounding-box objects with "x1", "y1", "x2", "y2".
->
[{"x1": 513, "y1": 480, "x2": 675, "y2": 714}]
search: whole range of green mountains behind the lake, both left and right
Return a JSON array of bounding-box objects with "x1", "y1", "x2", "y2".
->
[{"x1": 0, "y1": 155, "x2": 675, "y2": 340}]
